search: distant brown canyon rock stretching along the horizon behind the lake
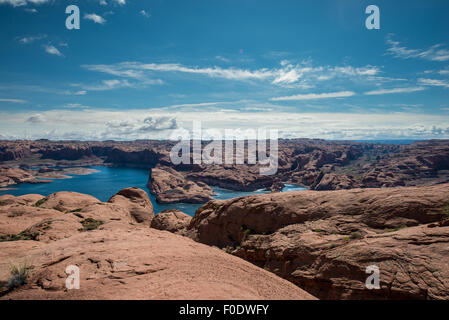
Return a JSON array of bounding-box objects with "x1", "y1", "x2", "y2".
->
[{"x1": 0, "y1": 139, "x2": 449, "y2": 203}]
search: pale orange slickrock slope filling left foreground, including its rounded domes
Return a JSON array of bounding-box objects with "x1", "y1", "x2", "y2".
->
[{"x1": 0, "y1": 188, "x2": 315, "y2": 299}]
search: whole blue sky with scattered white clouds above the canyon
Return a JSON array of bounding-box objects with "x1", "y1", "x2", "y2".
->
[{"x1": 0, "y1": 0, "x2": 449, "y2": 140}]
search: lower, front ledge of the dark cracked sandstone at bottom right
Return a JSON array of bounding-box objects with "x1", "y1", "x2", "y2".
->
[{"x1": 235, "y1": 222, "x2": 449, "y2": 300}]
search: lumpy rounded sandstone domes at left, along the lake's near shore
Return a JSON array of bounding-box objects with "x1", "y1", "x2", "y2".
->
[{"x1": 0, "y1": 188, "x2": 154, "y2": 241}]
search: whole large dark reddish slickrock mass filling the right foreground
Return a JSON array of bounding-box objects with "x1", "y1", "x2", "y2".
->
[{"x1": 188, "y1": 184, "x2": 449, "y2": 299}]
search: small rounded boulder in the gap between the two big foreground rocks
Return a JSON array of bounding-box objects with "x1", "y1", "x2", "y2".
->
[{"x1": 151, "y1": 209, "x2": 192, "y2": 234}]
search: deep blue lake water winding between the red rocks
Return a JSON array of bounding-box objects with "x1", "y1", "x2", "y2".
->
[{"x1": 0, "y1": 167, "x2": 306, "y2": 215}]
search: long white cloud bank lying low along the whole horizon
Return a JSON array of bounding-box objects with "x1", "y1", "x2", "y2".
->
[{"x1": 0, "y1": 108, "x2": 449, "y2": 140}]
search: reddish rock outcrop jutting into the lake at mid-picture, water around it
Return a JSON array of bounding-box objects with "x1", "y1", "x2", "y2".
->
[{"x1": 148, "y1": 167, "x2": 214, "y2": 203}]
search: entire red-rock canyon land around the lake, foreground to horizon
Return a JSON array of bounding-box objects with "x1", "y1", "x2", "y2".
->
[{"x1": 0, "y1": 139, "x2": 449, "y2": 300}]
